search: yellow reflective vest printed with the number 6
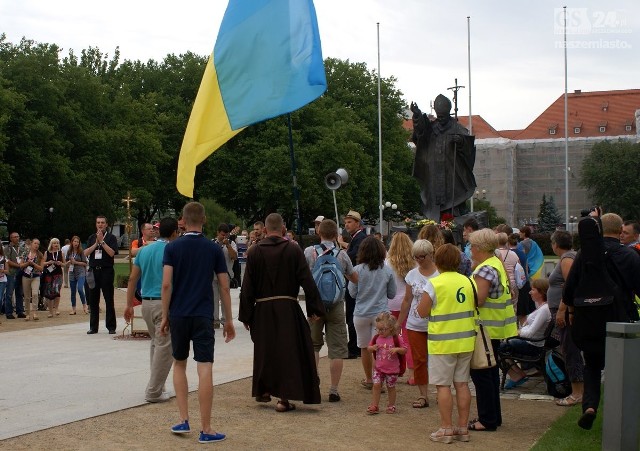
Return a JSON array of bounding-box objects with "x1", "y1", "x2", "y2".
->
[{"x1": 427, "y1": 272, "x2": 476, "y2": 354}]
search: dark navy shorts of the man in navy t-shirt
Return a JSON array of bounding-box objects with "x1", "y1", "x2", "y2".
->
[{"x1": 169, "y1": 316, "x2": 215, "y2": 362}]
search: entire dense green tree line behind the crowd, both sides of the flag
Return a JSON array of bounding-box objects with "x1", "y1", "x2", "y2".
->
[{"x1": 0, "y1": 35, "x2": 419, "y2": 237}]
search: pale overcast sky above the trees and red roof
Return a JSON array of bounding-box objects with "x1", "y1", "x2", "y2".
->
[{"x1": 0, "y1": 0, "x2": 640, "y2": 130}]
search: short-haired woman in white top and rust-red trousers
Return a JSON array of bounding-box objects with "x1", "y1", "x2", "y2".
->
[{"x1": 398, "y1": 240, "x2": 440, "y2": 409}]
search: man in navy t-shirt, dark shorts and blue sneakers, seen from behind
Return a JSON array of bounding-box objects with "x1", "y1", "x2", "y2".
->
[{"x1": 160, "y1": 202, "x2": 236, "y2": 443}]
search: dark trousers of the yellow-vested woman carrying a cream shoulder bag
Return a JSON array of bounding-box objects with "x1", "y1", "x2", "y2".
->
[{"x1": 471, "y1": 340, "x2": 502, "y2": 429}]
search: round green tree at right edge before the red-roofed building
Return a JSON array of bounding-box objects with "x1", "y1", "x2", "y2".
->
[{"x1": 580, "y1": 140, "x2": 640, "y2": 219}]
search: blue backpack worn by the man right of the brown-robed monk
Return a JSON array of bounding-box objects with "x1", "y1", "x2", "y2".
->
[{"x1": 311, "y1": 245, "x2": 346, "y2": 310}]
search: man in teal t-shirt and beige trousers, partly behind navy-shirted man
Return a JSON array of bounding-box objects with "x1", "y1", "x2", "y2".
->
[{"x1": 124, "y1": 218, "x2": 178, "y2": 402}]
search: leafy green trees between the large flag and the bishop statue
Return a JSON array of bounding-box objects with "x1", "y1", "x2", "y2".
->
[{"x1": 196, "y1": 58, "x2": 419, "y2": 228}]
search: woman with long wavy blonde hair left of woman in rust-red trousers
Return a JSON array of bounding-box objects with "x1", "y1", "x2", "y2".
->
[{"x1": 385, "y1": 233, "x2": 416, "y2": 385}]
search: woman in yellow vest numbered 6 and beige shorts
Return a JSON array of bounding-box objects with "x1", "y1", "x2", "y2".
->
[{"x1": 417, "y1": 244, "x2": 476, "y2": 443}]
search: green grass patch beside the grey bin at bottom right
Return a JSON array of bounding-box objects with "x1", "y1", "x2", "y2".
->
[{"x1": 531, "y1": 396, "x2": 603, "y2": 451}]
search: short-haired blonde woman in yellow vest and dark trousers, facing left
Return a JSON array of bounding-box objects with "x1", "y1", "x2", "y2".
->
[{"x1": 469, "y1": 229, "x2": 518, "y2": 431}]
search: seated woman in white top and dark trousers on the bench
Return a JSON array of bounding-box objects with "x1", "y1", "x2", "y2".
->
[{"x1": 500, "y1": 279, "x2": 551, "y2": 390}]
